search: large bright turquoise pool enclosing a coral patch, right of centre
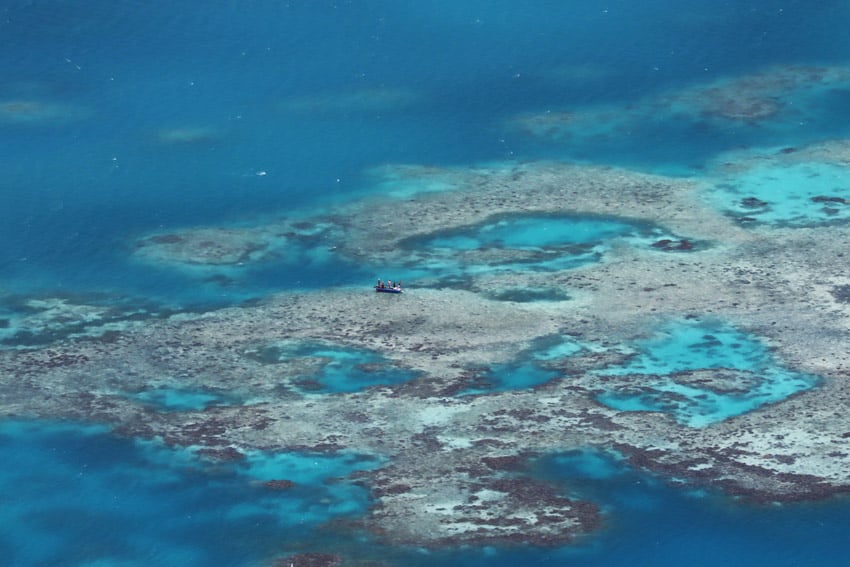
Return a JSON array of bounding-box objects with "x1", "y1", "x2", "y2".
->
[{"x1": 597, "y1": 321, "x2": 818, "y2": 427}]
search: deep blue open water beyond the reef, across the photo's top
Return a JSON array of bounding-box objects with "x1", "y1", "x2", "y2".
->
[{"x1": 0, "y1": 0, "x2": 847, "y2": 303}]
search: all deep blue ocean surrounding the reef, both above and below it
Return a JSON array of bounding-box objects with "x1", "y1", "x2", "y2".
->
[{"x1": 0, "y1": 0, "x2": 850, "y2": 566}]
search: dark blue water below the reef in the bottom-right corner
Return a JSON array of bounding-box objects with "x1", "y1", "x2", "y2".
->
[{"x1": 516, "y1": 451, "x2": 850, "y2": 566}]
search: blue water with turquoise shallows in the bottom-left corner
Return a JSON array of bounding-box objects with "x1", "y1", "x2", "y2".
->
[{"x1": 0, "y1": 421, "x2": 380, "y2": 566}]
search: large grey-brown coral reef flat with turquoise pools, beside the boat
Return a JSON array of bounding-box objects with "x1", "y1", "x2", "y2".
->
[{"x1": 0, "y1": 149, "x2": 850, "y2": 547}]
